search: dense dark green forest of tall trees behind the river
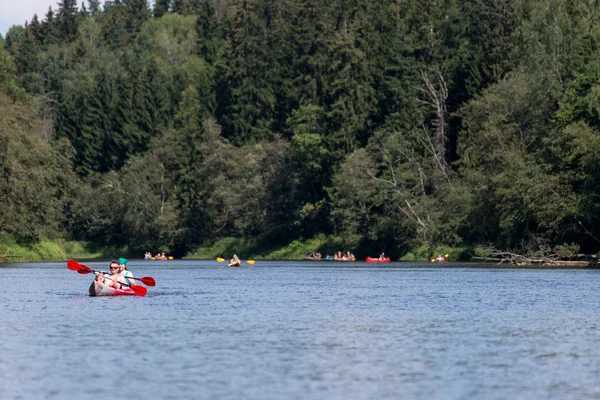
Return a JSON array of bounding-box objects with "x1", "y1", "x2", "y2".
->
[{"x1": 0, "y1": 0, "x2": 600, "y2": 257}]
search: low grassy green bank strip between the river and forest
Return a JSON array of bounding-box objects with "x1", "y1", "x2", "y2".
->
[{"x1": 0, "y1": 235, "x2": 598, "y2": 267}]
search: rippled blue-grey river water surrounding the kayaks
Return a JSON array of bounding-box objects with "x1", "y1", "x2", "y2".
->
[{"x1": 0, "y1": 261, "x2": 600, "y2": 400}]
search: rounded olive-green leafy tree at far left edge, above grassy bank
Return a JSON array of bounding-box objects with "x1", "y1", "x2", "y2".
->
[{"x1": 0, "y1": 93, "x2": 77, "y2": 244}]
